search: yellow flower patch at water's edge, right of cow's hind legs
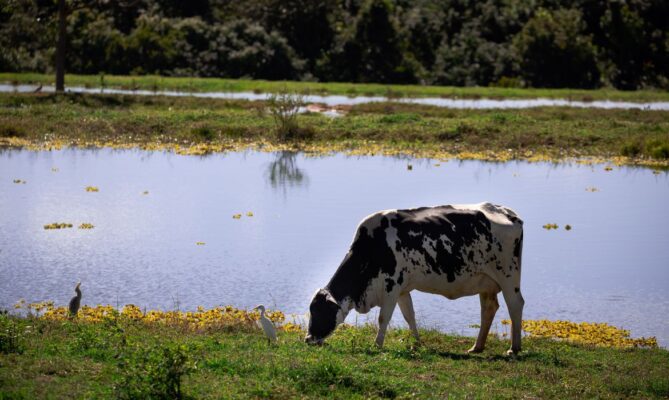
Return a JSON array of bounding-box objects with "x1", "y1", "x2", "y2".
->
[{"x1": 502, "y1": 319, "x2": 657, "y2": 348}]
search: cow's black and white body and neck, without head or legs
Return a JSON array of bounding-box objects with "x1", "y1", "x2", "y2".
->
[{"x1": 328, "y1": 203, "x2": 522, "y2": 312}]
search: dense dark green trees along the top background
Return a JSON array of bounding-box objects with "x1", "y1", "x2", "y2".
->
[{"x1": 0, "y1": 0, "x2": 669, "y2": 89}]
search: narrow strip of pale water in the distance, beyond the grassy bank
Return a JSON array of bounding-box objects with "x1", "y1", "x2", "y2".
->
[{"x1": 0, "y1": 84, "x2": 669, "y2": 110}]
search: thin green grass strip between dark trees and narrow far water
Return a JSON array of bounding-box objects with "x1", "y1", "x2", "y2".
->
[{"x1": 0, "y1": 73, "x2": 669, "y2": 102}]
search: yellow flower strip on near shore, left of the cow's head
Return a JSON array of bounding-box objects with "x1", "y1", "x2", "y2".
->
[{"x1": 22, "y1": 301, "x2": 302, "y2": 332}]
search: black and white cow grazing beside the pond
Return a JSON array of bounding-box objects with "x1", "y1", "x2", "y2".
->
[{"x1": 306, "y1": 203, "x2": 524, "y2": 353}]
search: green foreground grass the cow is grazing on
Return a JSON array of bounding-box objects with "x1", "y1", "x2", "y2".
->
[{"x1": 0, "y1": 316, "x2": 669, "y2": 399}]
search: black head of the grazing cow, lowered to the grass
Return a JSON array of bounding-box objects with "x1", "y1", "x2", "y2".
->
[{"x1": 305, "y1": 289, "x2": 343, "y2": 344}]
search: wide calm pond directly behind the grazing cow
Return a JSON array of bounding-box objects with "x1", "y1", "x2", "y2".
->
[{"x1": 0, "y1": 149, "x2": 669, "y2": 346}]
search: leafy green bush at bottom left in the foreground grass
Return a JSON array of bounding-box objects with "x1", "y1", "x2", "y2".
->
[{"x1": 114, "y1": 344, "x2": 197, "y2": 399}]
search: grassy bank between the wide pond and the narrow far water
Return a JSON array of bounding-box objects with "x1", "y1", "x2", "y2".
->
[{"x1": 0, "y1": 93, "x2": 669, "y2": 167}]
